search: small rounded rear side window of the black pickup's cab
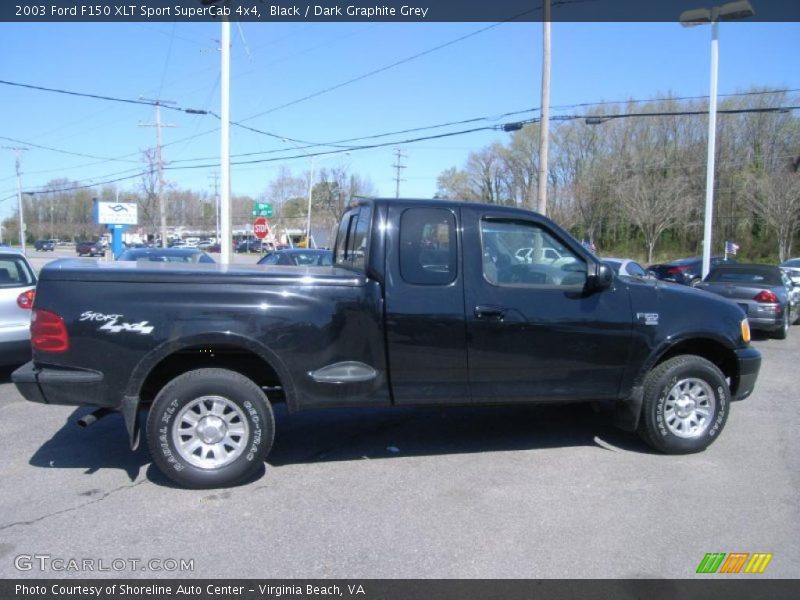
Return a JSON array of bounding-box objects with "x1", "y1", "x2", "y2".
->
[{"x1": 400, "y1": 208, "x2": 458, "y2": 285}]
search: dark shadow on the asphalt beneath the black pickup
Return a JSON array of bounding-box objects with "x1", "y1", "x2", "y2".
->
[{"x1": 30, "y1": 398, "x2": 649, "y2": 486}]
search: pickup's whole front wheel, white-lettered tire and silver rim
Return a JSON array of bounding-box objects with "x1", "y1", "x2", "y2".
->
[{"x1": 639, "y1": 355, "x2": 730, "y2": 454}]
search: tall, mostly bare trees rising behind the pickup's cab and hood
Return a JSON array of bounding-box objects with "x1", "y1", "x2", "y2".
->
[{"x1": 437, "y1": 89, "x2": 800, "y2": 263}]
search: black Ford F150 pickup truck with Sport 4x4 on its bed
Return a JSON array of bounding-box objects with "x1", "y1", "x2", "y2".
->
[{"x1": 12, "y1": 199, "x2": 761, "y2": 488}]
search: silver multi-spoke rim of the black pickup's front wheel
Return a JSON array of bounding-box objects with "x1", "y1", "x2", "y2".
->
[{"x1": 664, "y1": 378, "x2": 716, "y2": 439}]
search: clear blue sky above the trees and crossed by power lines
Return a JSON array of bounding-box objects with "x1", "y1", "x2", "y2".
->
[{"x1": 0, "y1": 18, "x2": 800, "y2": 224}]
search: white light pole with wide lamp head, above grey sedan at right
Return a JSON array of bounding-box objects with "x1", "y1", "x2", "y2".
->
[{"x1": 679, "y1": 0, "x2": 755, "y2": 279}]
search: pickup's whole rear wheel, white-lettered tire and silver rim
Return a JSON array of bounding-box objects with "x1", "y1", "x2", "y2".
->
[{"x1": 147, "y1": 369, "x2": 275, "y2": 488}]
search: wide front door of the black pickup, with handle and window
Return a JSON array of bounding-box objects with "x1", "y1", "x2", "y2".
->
[{"x1": 462, "y1": 208, "x2": 632, "y2": 403}]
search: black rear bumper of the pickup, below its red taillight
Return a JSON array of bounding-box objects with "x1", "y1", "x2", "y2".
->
[{"x1": 11, "y1": 362, "x2": 111, "y2": 406}]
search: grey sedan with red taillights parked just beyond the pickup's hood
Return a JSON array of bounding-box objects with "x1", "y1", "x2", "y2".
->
[{"x1": 697, "y1": 264, "x2": 800, "y2": 339}]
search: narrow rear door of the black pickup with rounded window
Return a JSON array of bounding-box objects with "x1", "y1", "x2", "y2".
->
[{"x1": 385, "y1": 204, "x2": 469, "y2": 404}]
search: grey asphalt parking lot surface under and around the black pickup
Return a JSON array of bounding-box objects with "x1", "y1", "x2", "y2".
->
[{"x1": 0, "y1": 255, "x2": 800, "y2": 579}]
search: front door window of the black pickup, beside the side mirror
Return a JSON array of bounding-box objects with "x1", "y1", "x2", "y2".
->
[{"x1": 481, "y1": 219, "x2": 586, "y2": 288}]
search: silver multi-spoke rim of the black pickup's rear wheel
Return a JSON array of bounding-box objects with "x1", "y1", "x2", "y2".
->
[{"x1": 172, "y1": 396, "x2": 250, "y2": 469}]
